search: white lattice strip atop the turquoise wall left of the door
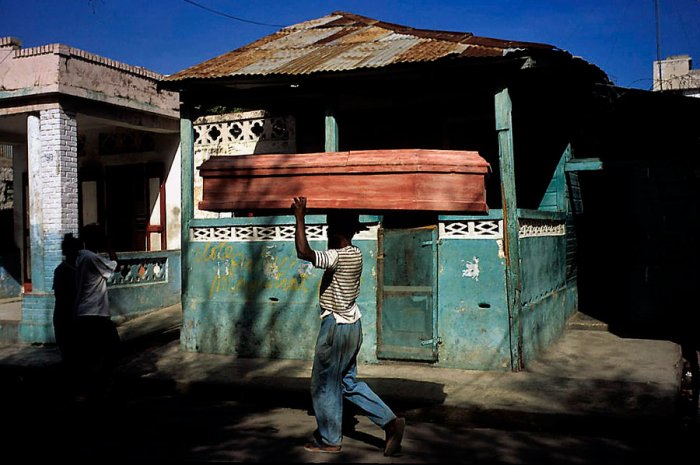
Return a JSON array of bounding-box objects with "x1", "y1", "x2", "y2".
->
[{"x1": 190, "y1": 225, "x2": 379, "y2": 242}]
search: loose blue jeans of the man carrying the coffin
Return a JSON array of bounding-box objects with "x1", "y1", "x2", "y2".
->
[{"x1": 311, "y1": 315, "x2": 396, "y2": 446}]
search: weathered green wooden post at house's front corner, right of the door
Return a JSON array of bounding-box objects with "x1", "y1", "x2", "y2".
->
[{"x1": 495, "y1": 88, "x2": 523, "y2": 371}]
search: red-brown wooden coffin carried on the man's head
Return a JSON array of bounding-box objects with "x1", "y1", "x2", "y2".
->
[{"x1": 199, "y1": 149, "x2": 490, "y2": 212}]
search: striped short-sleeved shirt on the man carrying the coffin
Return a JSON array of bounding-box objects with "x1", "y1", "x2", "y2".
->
[{"x1": 314, "y1": 245, "x2": 362, "y2": 323}]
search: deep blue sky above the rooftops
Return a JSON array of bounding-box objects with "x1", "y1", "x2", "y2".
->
[{"x1": 0, "y1": 0, "x2": 700, "y2": 89}]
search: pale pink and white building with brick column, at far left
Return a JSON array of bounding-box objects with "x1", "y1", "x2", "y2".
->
[{"x1": 0, "y1": 37, "x2": 180, "y2": 342}]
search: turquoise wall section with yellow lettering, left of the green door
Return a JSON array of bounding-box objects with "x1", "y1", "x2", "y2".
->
[{"x1": 182, "y1": 240, "x2": 377, "y2": 362}]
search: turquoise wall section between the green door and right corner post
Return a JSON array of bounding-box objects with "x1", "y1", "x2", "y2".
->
[{"x1": 438, "y1": 239, "x2": 510, "y2": 370}]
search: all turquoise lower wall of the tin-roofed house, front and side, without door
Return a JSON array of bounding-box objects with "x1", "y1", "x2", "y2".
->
[{"x1": 181, "y1": 212, "x2": 575, "y2": 371}]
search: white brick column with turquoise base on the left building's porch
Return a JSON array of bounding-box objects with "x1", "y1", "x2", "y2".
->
[{"x1": 20, "y1": 107, "x2": 78, "y2": 342}]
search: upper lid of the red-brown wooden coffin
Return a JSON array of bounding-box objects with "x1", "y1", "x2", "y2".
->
[{"x1": 198, "y1": 149, "x2": 490, "y2": 178}]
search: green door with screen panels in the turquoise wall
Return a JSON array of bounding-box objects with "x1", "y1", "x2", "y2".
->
[{"x1": 377, "y1": 226, "x2": 437, "y2": 361}]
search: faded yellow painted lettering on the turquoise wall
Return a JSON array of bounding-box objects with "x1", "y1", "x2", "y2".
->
[{"x1": 193, "y1": 242, "x2": 315, "y2": 297}]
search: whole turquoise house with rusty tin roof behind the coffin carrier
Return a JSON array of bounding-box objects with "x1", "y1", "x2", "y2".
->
[{"x1": 162, "y1": 12, "x2": 609, "y2": 371}]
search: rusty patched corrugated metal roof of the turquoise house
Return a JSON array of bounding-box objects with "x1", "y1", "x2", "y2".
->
[{"x1": 165, "y1": 12, "x2": 555, "y2": 81}]
